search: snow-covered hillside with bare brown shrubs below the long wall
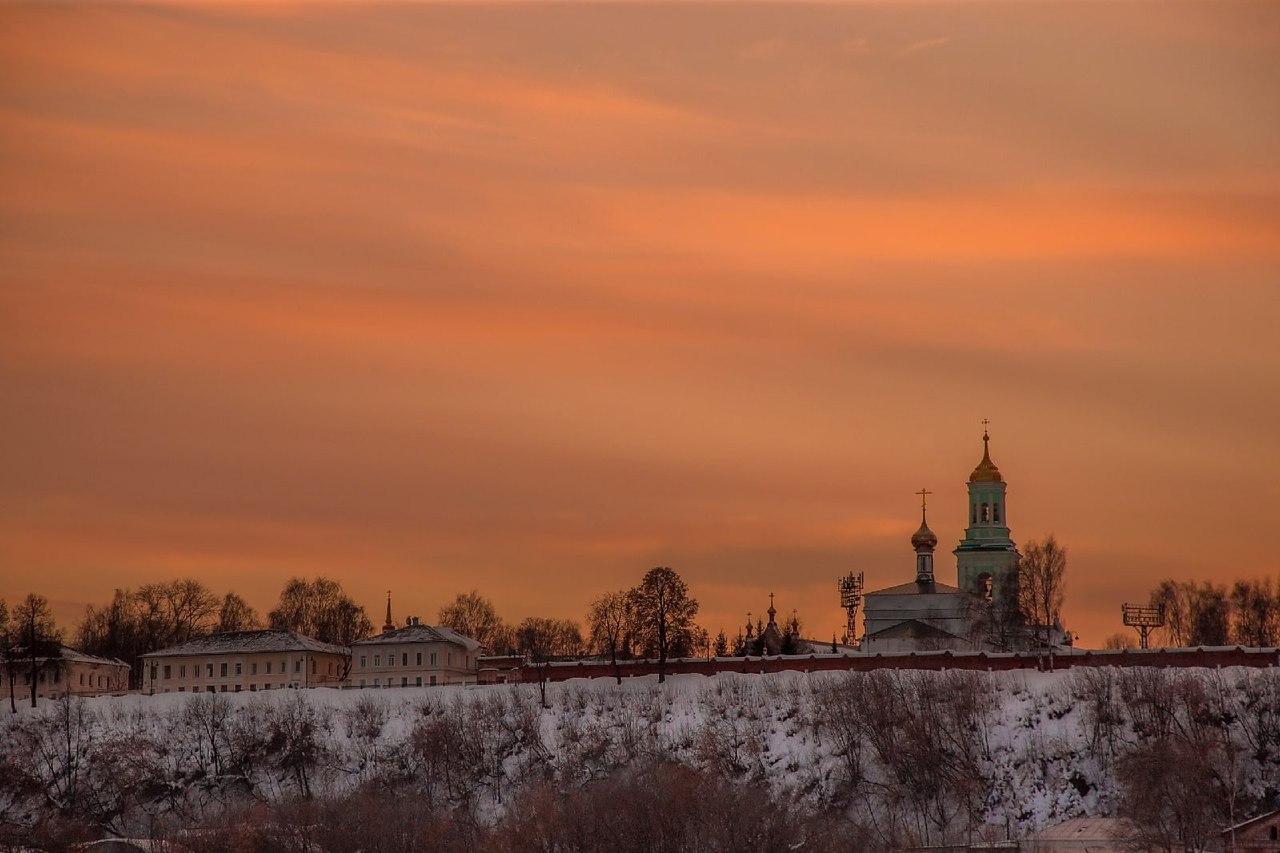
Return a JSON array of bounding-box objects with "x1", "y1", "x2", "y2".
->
[{"x1": 0, "y1": 669, "x2": 1280, "y2": 849}]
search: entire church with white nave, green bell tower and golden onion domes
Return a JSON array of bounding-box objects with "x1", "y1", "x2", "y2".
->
[{"x1": 861, "y1": 424, "x2": 1062, "y2": 653}]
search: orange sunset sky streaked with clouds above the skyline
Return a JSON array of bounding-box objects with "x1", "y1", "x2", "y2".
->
[{"x1": 0, "y1": 0, "x2": 1280, "y2": 646}]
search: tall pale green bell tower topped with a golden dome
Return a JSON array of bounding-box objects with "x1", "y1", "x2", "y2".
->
[{"x1": 955, "y1": 420, "x2": 1019, "y2": 599}]
